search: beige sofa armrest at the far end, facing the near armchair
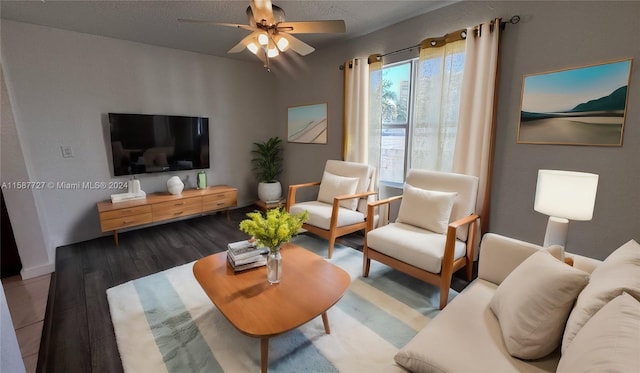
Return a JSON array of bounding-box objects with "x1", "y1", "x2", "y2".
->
[{"x1": 478, "y1": 233, "x2": 542, "y2": 285}]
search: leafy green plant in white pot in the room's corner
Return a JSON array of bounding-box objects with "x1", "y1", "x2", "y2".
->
[{"x1": 251, "y1": 136, "x2": 282, "y2": 202}]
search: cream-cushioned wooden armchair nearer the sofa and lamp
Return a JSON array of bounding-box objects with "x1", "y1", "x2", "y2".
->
[{"x1": 362, "y1": 169, "x2": 479, "y2": 309}]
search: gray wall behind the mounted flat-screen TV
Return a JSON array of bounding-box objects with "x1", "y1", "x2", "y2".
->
[{"x1": 1, "y1": 20, "x2": 276, "y2": 277}]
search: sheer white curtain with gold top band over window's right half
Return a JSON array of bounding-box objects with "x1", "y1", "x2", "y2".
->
[{"x1": 409, "y1": 40, "x2": 465, "y2": 171}]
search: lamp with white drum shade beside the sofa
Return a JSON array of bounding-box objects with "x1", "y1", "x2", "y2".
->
[{"x1": 533, "y1": 170, "x2": 598, "y2": 247}]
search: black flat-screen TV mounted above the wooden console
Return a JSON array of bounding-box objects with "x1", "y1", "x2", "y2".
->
[{"x1": 109, "y1": 113, "x2": 209, "y2": 176}]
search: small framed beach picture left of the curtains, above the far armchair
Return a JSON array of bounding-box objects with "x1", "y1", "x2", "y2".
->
[{"x1": 287, "y1": 103, "x2": 328, "y2": 144}]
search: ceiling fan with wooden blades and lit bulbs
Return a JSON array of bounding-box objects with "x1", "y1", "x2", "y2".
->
[{"x1": 178, "y1": 0, "x2": 345, "y2": 71}]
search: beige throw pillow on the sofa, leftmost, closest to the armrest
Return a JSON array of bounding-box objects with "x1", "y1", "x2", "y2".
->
[{"x1": 489, "y1": 250, "x2": 589, "y2": 359}]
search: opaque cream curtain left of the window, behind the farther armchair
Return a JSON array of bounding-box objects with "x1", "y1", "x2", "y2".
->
[{"x1": 342, "y1": 58, "x2": 369, "y2": 163}]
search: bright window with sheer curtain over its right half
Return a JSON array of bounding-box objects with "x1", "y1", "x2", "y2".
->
[{"x1": 370, "y1": 41, "x2": 465, "y2": 184}]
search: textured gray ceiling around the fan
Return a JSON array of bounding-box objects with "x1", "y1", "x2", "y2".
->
[{"x1": 0, "y1": 0, "x2": 459, "y2": 59}]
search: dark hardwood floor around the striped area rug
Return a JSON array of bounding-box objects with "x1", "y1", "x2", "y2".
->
[{"x1": 37, "y1": 206, "x2": 467, "y2": 373}]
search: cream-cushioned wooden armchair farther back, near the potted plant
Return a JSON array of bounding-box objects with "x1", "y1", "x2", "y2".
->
[{"x1": 287, "y1": 160, "x2": 376, "y2": 258}]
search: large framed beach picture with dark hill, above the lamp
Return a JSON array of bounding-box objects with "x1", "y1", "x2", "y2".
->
[{"x1": 518, "y1": 59, "x2": 632, "y2": 146}]
